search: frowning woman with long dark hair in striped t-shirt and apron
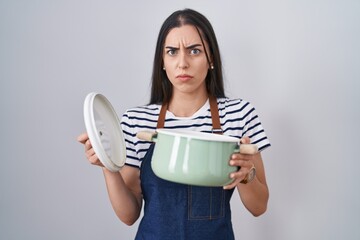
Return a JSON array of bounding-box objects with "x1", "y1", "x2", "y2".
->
[{"x1": 78, "y1": 9, "x2": 270, "y2": 240}]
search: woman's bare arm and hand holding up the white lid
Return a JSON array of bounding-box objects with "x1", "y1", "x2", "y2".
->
[{"x1": 78, "y1": 133, "x2": 142, "y2": 225}]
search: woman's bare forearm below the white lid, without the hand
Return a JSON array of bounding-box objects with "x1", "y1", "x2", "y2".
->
[{"x1": 103, "y1": 169, "x2": 142, "y2": 225}]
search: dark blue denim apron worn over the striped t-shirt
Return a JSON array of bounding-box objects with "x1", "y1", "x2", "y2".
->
[{"x1": 135, "y1": 97, "x2": 234, "y2": 240}]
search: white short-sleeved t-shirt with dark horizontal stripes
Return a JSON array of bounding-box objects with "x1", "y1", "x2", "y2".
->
[{"x1": 121, "y1": 98, "x2": 270, "y2": 167}]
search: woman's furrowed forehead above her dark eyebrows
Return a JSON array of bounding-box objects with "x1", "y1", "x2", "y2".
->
[{"x1": 165, "y1": 25, "x2": 201, "y2": 45}]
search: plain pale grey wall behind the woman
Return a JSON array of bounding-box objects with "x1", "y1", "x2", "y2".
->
[{"x1": 0, "y1": 0, "x2": 360, "y2": 240}]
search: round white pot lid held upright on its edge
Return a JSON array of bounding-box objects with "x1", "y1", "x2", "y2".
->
[{"x1": 84, "y1": 92, "x2": 126, "y2": 172}]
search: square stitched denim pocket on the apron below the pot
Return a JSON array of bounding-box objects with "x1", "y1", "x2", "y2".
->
[{"x1": 188, "y1": 186, "x2": 225, "y2": 220}]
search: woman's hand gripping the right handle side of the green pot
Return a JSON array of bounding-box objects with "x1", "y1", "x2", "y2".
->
[{"x1": 224, "y1": 137, "x2": 255, "y2": 189}]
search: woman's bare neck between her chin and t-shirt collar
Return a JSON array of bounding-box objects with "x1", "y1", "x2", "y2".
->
[{"x1": 168, "y1": 91, "x2": 208, "y2": 117}]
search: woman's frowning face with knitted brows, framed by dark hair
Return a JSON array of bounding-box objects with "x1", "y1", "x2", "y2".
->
[{"x1": 163, "y1": 25, "x2": 210, "y2": 97}]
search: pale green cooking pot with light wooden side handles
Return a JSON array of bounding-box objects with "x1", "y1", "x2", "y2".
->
[{"x1": 137, "y1": 128, "x2": 258, "y2": 186}]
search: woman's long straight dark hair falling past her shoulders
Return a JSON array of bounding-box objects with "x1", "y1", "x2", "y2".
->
[{"x1": 150, "y1": 9, "x2": 225, "y2": 104}]
